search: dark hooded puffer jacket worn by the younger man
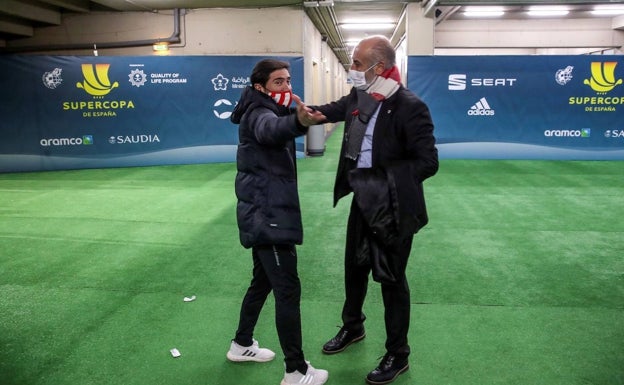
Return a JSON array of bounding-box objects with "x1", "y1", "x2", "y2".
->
[{"x1": 230, "y1": 87, "x2": 308, "y2": 248}]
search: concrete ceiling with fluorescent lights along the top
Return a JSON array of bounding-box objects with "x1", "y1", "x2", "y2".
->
[{"x1": 0, "y1": 0, "x2": 624, "y2": 63}]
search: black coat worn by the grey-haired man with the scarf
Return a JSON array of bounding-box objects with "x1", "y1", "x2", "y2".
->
[{"x1": 315, "y1": 86, "x2": 439, "y2": 234}]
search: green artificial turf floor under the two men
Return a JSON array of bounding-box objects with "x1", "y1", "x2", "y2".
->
[{"x1": 0, "y1": 130, "x2": 624, "y2": 385}]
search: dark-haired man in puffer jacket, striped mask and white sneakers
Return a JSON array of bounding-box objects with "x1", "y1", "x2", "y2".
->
[{"x1": 227, "y1": 59, "x2": 328, "y2": 385}]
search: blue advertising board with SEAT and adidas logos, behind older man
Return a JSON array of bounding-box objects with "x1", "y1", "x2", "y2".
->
[{"x1": 407, "y1": 55, "x2": 624, "y2": 160}]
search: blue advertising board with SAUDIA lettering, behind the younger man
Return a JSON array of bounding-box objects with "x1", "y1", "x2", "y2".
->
[{"x1": 0, "y1": 56, "x2": 303, "y2": 172}]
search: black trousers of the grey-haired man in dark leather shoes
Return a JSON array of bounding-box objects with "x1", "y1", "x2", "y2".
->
[{"x1": 342, "y1": 200, "x2": 413, "y2": 355}]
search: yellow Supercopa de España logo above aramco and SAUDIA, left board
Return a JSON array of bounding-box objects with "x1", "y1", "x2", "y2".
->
[{"x1": 63, "y1": 63, "x2": 134, "y2": 118}]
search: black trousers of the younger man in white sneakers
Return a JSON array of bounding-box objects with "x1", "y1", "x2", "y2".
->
[{"x1": 234, "y1": 245, "x2": 308, "y2": 373}]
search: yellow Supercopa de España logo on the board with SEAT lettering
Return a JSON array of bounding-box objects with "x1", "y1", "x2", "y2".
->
[{"x1": 568, "y1": 61, "x2": 624, "y2": 112}]
